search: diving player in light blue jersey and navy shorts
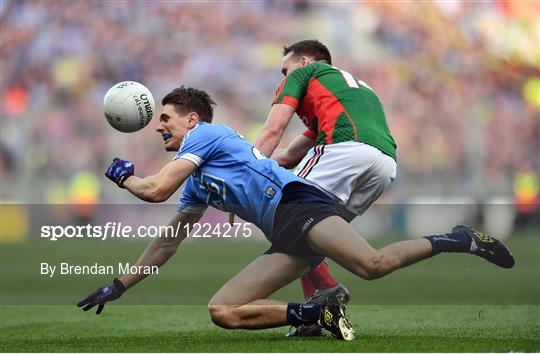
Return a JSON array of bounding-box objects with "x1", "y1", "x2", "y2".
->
[{"x1": 78, "y1": 87, "x2": 514, "y2": 340}]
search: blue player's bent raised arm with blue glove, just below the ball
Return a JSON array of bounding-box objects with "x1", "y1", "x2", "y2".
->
[{"x1": 105, "y1": 159, "x2": 197, "y2": 203}]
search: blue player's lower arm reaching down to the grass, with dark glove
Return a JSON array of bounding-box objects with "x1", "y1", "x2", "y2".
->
[{"x1": 77, "y1": 212, "x2": 202, "y2": 315}]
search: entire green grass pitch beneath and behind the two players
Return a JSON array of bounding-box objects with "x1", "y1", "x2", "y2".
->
[{"x1": 0, "y1": 235, "x2": 540, "y2": 352}]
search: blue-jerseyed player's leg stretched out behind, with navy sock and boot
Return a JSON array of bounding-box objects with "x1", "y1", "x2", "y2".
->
[{"x1": 307, "y1": 216, "x2": 514, "y2": 280}]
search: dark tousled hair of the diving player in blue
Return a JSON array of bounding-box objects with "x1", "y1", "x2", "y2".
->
[{"x1": 161, "y1": 86, "x2": 216, "y2": 123}]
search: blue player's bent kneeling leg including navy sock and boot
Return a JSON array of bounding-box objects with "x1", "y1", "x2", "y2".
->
[{"x1": 209, "y1": 253, "x2": 354, "y2": 340}]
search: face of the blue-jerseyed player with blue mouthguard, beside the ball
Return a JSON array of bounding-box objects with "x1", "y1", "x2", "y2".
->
[{"x1": 156, "y1": 104, "x2": 199, "y2": 151}]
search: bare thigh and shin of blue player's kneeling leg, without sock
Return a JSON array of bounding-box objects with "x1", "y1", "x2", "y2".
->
[{"x1": 209, "y1": 253, "x2": 309, "y2": 329}]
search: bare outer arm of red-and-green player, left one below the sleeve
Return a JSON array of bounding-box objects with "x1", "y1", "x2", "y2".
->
[{"x1": 255, "y1": 103, "x2": 295, "y2": 156}]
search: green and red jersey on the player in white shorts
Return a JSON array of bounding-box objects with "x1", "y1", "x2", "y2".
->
[{"x1": 273, "y1": 62, "x2": 397, "y2": 160}]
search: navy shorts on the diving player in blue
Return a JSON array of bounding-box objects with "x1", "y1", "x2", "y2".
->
[{"x1": 265, "y1": 182, "x2": 339, "y2": 269}]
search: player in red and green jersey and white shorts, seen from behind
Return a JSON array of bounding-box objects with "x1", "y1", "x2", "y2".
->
[{"x1": 255, "y1": 40, "x2": 397, "y2": 335}]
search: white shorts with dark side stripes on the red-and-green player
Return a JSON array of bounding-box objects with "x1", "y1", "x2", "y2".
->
[{"x1": 294, "y1": 141, "x2": 397, "y2": 221}]
